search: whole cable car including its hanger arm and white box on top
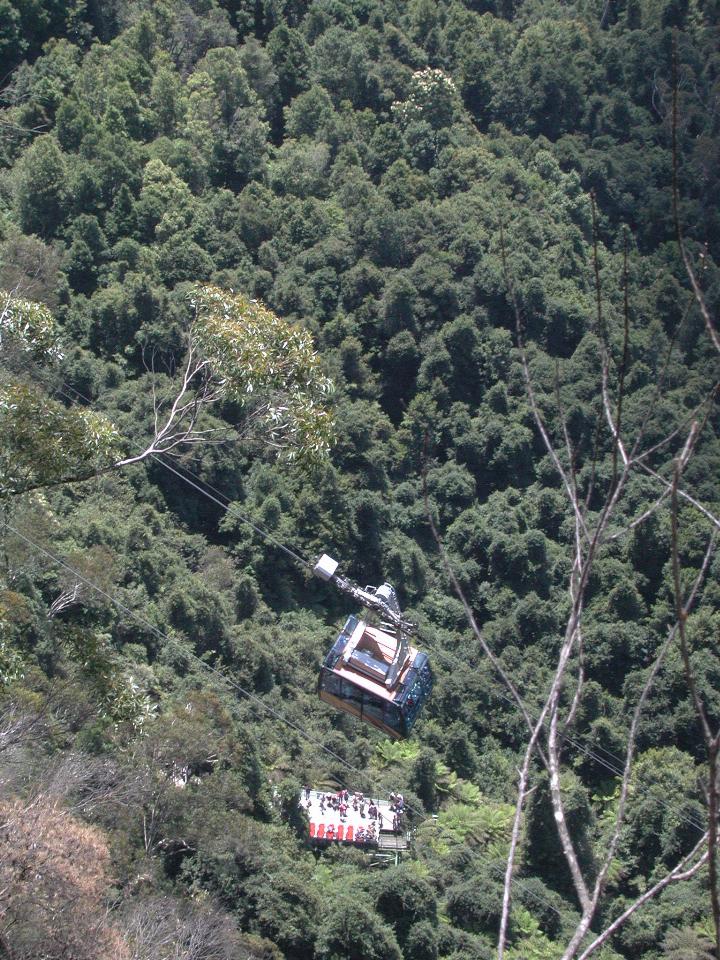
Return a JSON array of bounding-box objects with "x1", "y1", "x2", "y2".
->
[{"x1": 314, "y1": 554, "x2": 433, "y2": 740}]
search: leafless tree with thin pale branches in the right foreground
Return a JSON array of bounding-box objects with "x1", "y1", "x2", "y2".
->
[{"x1": 427, "y1": 204, "x2": 720, "y2": 960}]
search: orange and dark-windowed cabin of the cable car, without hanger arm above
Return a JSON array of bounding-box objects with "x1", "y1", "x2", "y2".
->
[{"x1": 318, "y1": 617, "x2": 433, "y2": 740}]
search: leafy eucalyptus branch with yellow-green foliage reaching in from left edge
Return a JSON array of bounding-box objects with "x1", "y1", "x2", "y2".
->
[{"x1": 0, "y1": 285, "x2": 332, "y2": 496}]
